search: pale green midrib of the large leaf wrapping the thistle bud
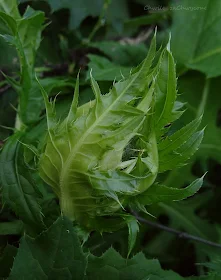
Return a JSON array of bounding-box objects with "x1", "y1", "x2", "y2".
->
[{"x1": 60, "y1": 71, "x2": 143, "y2": 186}]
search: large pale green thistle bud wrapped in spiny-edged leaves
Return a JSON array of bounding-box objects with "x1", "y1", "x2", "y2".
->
[{"x1": 39, "y1": 34, "x2": 203, "y2": 249}]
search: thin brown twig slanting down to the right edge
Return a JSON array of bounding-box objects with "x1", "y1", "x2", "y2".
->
[{"x1": 132, "y1": 211, "x2": 221, "y2": 249}]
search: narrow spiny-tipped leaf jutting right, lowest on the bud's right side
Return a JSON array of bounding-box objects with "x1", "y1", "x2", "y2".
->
[{"x1": 135, "y1": 176, "x2": 204, "y2": 205}]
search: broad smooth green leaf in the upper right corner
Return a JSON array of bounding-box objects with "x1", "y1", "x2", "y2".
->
[{"x1": 171, "y1": 0, "x2": 221, "y2": 77}]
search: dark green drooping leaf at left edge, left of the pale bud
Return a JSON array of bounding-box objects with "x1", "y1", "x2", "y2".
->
[{"x1": 0, "y1": 132, "x2": 43, "y2": 232}]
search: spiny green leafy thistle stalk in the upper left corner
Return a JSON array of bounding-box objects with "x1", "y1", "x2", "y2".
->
[{"x1": 0, "y1": 0, "x2": 44, "y2": 128}]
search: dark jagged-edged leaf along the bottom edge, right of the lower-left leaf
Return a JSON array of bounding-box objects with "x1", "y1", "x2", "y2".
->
[{"x1": 86, "y1": 248, "x2": 184, "y2": 280}]
